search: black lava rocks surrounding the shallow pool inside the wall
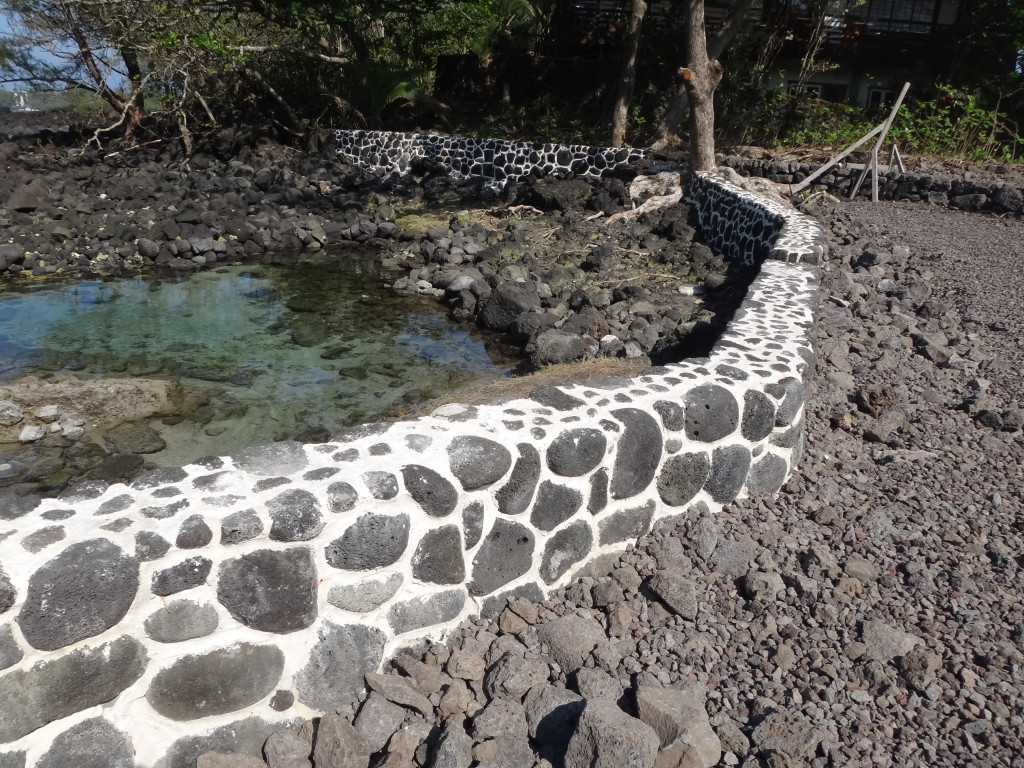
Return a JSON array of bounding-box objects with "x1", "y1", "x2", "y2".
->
[{"x1": 0, "y1": 123, "x2": 753, "y2": 496}]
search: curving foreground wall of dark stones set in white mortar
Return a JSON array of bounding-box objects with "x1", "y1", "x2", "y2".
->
[{"x1": 0, "y1": 157, "x2": 822, "y2": 768}]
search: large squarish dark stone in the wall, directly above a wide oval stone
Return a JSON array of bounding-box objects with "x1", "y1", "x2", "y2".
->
[{"x1": 217, "y1": 547, "x2": 316, "y2": 634}]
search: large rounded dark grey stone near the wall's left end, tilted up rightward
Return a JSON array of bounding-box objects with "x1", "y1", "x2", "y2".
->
[{"x1": 17, "y1": 539, "x2": 138, "y2": 650}]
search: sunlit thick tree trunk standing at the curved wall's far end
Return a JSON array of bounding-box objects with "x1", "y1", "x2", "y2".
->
[{"x1": 680, "y1": 0, "x2": 722, "y2": 173}]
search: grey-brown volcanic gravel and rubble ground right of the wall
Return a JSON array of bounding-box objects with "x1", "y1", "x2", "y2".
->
[{"x1": 249, "y1": 198, "x2": 1024, "y2": 768}]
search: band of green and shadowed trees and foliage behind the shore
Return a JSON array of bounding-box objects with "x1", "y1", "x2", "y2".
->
[{"x1": 0, "y1": 0, "x2": 1024, "y2": 158}]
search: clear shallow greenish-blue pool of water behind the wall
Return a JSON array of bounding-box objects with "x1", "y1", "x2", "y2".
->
[{"x1": 0, "y1": 252, "x2": 515, "y2": 465}]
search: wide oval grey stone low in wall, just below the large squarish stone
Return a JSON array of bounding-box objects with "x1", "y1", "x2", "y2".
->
[{"x1": 145, "y1": 643, "x2": 285, "y2": 721}]
